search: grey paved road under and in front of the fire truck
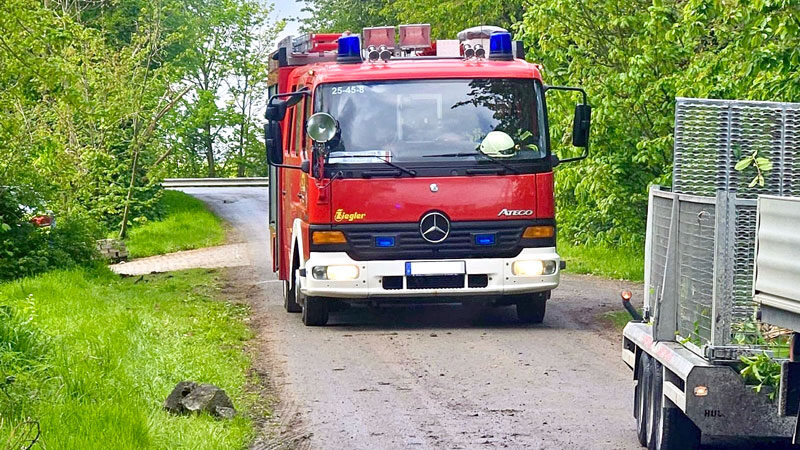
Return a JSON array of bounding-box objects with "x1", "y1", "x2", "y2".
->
[{"x1": 183, "y1": 188, "x2": 641, "y2": 449}]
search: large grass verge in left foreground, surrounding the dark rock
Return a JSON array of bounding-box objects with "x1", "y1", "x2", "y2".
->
[{"x1": 0, "y1": 268, "x2": 256, "y2": 449}]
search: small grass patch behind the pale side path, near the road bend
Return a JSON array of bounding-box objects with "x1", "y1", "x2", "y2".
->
[{"x1": 125, "y1": 191, "x2": 225, "y2": 258}]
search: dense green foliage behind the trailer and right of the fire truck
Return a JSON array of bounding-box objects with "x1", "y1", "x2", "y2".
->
[{"x1": 306, "y1": 0, "x2": 800, "y2": 247}]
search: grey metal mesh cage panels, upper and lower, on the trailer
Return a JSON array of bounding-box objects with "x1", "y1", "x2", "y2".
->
[{"x1": 645, "y1": 98, "x2": 800, "y2": 356}]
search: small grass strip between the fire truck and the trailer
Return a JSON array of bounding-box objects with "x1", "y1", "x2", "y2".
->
[{"x1": 558, "y1": 239, "x2": 644, "y2": 281}]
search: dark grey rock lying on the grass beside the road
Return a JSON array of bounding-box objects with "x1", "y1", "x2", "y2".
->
[{"x1": 164, "y1": 381, "x2": 236, "y2": 419}]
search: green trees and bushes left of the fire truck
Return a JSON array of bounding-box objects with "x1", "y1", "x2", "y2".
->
[{"x1": 0, "y1": 0, "x2": 279, "y2": 278}]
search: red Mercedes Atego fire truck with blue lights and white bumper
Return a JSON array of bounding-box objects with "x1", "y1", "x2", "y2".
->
[{"x1": 265, "y1": 25, "x2": 591, "y2": 325}]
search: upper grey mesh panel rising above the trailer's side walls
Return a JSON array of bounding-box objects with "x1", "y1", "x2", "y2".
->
[{"x1": 672, "y1": 98, "x2": 800, "y2": 198}]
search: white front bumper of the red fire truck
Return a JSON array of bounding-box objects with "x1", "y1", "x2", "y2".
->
[{"x1": 300, "y1": 247, "x2": 561, "y2": 299}]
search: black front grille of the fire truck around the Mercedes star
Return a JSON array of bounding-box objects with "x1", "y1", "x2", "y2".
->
[{"x1": 311, "y1": 219, "x2": 555, "y2": 261}]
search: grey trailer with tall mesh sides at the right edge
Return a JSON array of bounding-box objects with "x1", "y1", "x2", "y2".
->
[{"x1": 622, "y1": 98, "x2": 800, "y2": 449}]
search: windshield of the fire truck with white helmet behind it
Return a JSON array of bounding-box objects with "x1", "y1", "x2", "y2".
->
[{"x1": 316, "y1": 78, "x2": 546, "y2": 164}]
